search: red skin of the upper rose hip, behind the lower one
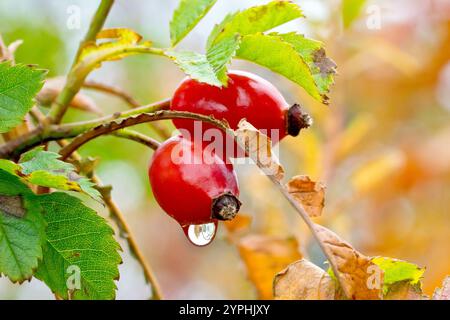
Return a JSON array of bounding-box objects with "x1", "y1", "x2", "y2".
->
[{"x1": 171, "y1": 71, "x2": 289, "y2": 156}]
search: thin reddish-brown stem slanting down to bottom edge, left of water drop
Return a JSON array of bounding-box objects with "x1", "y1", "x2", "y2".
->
[{"x1": 58, "y1": 140, "x2": 162, "y2": 300}]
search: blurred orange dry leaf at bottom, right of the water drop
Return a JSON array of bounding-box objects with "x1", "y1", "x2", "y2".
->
[{"x1": 238, "y1": 235, "x2": 302, "y2": 299}]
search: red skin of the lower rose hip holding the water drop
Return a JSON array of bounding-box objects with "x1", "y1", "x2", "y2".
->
[{"x1": 148, "y1": 136, "x2": 239, "y2": 227}]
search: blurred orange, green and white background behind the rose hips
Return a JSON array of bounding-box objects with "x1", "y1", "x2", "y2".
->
[{"x1": 0, "y1": 0, "x2": 450, "y2": 299}]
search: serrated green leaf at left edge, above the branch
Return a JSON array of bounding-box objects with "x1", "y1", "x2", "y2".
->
[{"x1": 0, "y1": 62, "x2": 46, "y2": 133}]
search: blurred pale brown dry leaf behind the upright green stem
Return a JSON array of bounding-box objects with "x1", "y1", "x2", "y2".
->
[{"x1": 36, "y1": 77, "x2": 102, "y2": 115}]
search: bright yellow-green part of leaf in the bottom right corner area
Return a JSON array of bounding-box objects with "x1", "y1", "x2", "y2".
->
[{"x1": 372, "y1": 257, "x2": 425, "y2": 294}]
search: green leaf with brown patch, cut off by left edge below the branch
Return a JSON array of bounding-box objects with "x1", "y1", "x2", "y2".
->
[{"x1": 0, "y1": 170, "x2": 45, "y2": 282}]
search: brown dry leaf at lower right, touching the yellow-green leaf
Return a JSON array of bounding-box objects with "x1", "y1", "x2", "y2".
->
[{"x1": 314, "y1": 224, "x2": 383, "y2": 300}]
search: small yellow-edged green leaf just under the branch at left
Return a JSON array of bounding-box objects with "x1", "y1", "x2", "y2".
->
[{"x1": 0, "y1": 147, "x2": 101, "y2": 202}]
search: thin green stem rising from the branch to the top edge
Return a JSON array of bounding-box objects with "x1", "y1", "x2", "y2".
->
[{"x1": 48, "y1": 0, "x2": 114, "y2": 123}]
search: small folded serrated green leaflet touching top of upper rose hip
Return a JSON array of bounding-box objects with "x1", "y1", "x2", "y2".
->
[{"x1": 206, "y1": 34, "x2": 241, "y2": 85}]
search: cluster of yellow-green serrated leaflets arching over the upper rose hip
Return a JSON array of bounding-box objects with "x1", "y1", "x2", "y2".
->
[{"x1": 166, "y1": 1, "x2": 336, "y2": 103}]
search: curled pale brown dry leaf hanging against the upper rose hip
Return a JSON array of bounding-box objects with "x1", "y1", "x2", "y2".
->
[{"x1": 235, "y1": 119, "x2": 284, "y2": 181}]
